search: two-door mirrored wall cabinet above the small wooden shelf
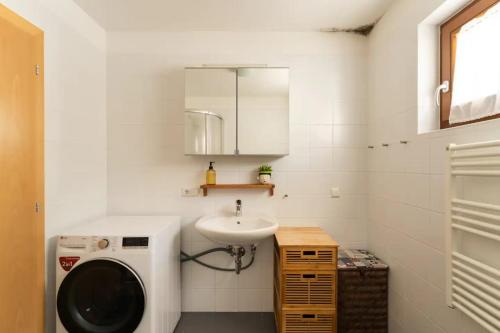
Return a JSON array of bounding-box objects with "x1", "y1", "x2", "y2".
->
[{"x1": 184, "y1": 67, "x2": 289, "y2": 156}]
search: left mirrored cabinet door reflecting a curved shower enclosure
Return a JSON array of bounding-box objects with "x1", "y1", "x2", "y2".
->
[{"x1": 184, "y1": 68, "x2": 236, "y2": 155}]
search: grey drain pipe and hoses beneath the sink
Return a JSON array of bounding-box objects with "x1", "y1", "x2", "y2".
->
[{"x1": 181, "y1": 245, "x2": 257, "y2": 274}]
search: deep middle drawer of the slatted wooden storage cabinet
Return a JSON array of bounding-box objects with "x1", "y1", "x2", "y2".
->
[{"x1": 282, "y1": 271, "x2": 336, "y2": 308}]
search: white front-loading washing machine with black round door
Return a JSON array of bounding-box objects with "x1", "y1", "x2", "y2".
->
[{"x1": 56, "y1": 216, "x2": 181, "y2": 333}]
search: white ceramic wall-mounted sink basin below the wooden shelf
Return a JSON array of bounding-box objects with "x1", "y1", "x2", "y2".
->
[{"x1": 196, "y1": 216, "x2": 278, "y2": 246}]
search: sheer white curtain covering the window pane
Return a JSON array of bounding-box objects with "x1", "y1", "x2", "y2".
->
[{"x1": 449, "y1": 4, "x2": 500, "y2": 124}]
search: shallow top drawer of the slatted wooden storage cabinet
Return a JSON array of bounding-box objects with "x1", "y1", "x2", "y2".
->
[{"x1": 281, "y1": 247, "x2": 337, "y2": 270}]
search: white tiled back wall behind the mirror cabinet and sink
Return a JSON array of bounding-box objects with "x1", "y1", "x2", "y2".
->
[{"x1": 107, "y1": 32, "x2": 367, "y2": 311}]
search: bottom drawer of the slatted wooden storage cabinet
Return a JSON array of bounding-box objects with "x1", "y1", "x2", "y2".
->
[{"x1": 282, "y1": 310, "x2": 336, "y2": 333}]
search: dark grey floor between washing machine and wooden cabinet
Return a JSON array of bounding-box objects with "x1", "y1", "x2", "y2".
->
[{"x1": 174, "y1": 312, "x2": 275, "y2": 333}]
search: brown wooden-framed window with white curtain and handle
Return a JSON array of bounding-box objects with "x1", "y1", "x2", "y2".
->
[{"x1": 438, "y1": 0, "x2": 500, "y2": 128}]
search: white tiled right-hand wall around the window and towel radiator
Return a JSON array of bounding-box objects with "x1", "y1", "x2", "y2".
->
[{"x1": 368, "y1": 0, "x2": 500, "y2": 333}]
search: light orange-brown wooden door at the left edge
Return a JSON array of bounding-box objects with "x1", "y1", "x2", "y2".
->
[{"x1": 0, "y1": 5, "x2": 45, "y2": 333}]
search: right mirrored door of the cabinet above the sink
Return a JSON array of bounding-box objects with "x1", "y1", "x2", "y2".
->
[{"x1": 238, "y1": 68, "x2": 289, "y2": 155}]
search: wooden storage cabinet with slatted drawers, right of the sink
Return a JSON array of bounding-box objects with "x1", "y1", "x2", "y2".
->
[{"x1": 274, "y1": 228, "x2": 338, "y2": 333}]
